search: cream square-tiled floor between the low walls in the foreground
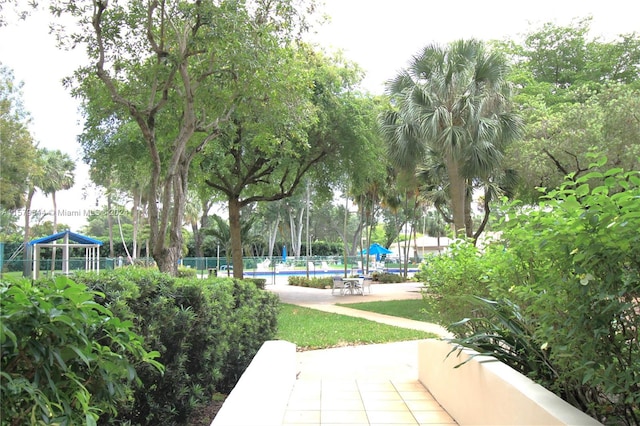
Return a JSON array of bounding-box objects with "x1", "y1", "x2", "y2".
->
[{"x1": 283, "y1": 379, "x2": 456, "y2": 426}]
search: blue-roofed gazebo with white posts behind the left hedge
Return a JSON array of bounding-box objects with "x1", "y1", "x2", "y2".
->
[{"x1": 29, "y1": 230, "x2": 102, "y2": 279}]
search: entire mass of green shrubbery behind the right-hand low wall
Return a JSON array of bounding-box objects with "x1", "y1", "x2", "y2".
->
[{"x1": 420, "y1": 160, "x2": 640, "y2": 425}]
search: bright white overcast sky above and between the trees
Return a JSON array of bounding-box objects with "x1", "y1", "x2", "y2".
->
[{"x1": 0, "y1": 0, "x2": 640, "y2": 231}]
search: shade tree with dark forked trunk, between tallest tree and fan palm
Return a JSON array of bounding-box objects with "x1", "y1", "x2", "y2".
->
[{"x1": 200, "y1": 49, "x2": 374, "y2": 278}]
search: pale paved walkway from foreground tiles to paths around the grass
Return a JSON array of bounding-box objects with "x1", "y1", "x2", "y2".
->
[{"x1": 266, "y1": 283, "x2": 455, "y2": 426}]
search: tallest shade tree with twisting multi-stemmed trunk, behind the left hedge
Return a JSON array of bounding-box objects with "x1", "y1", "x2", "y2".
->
[{"x1": 52, "y1": 0, "x2": 316, "y2": 274}]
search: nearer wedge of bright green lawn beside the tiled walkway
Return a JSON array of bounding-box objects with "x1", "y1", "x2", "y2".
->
[{"x1": 276, "y1": 303, "x2": 436, "y2": 350}]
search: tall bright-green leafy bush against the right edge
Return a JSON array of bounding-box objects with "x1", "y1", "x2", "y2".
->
[{"x1": 496, "y1": 164, "x2": 640, "y2": 424}]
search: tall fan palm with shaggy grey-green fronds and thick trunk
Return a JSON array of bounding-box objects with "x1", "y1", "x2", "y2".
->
[{"x1": 380, "y1": 40, "x2": 522, "y2": 237}]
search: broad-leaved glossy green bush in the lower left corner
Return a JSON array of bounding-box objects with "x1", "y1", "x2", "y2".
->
[{"x1": 0, "y1": 277, "x2": 162, "y2": 425}]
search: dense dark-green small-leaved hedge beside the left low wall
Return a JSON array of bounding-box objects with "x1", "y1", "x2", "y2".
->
[{"x1": 78, "y1": 268, "x2": 278, "y2": 424}]
